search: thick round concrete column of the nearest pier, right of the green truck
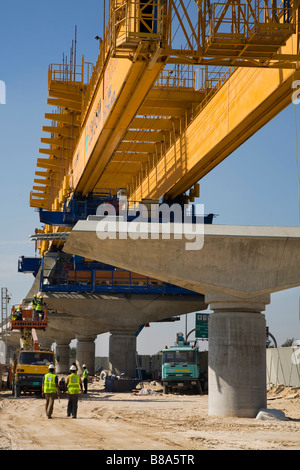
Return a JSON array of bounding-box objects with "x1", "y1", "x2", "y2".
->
[{"x1": 206, "y1": 293, "x2": 270, "y2": 418}]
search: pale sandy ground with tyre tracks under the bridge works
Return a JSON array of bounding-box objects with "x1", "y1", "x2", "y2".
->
[{"x1": 0, "y1": 382, "x2": 300, "y2": 451}]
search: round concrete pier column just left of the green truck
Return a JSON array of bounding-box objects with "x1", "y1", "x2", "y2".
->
[{"x1": 109, "y1": 331, "x2": 136, "y2": 379}]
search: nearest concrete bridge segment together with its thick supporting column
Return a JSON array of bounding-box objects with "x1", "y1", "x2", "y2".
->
[{"x1": 64, "y1": 220, "x2": 300, "y2": 417}]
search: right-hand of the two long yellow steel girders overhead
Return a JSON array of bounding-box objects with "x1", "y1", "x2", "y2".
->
[{"x1": 129, "y1": 30, "x2": 300, "y2": 200}]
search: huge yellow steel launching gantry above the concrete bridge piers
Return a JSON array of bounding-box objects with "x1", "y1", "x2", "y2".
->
[{"x1": 30, "y1": 0, "x2": 300, "y2": 255}]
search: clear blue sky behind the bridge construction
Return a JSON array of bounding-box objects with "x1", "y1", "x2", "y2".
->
[{"x1": 0, "y1": 0, "x2": 300, "y2": 353}]
